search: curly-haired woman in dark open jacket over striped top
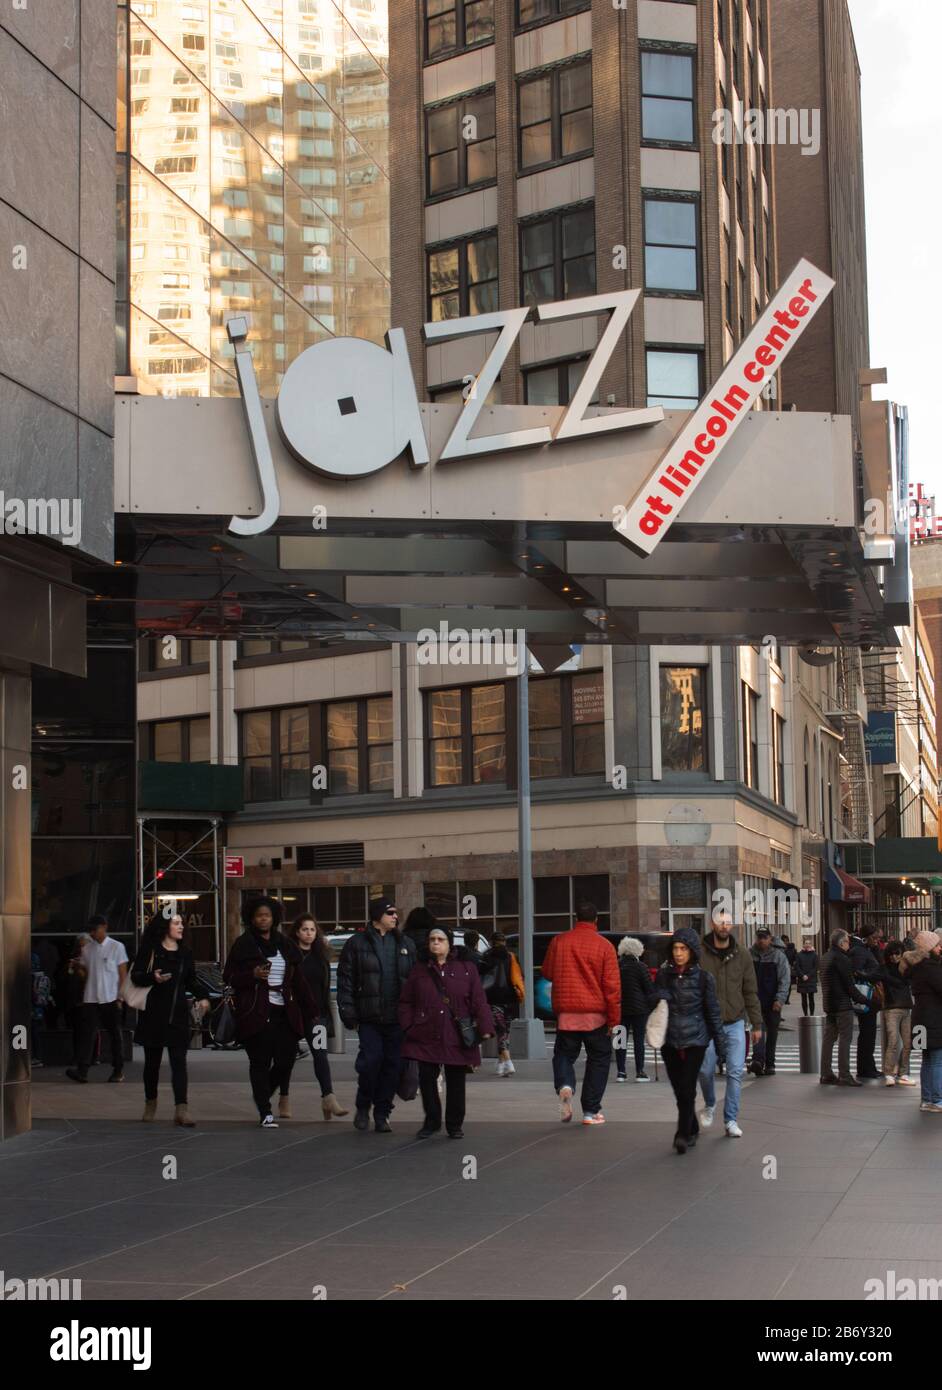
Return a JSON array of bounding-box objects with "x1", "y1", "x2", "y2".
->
[{"x1": 222, "y1": 898, "x2": 314, "y2": 1129}]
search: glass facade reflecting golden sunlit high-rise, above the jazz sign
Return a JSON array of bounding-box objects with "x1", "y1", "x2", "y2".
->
[{"x1": 115, "y1": 0, "x2": 389, "y2": 396}]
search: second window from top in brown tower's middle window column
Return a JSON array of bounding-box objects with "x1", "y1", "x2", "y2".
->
[{"x1": 517, "y1": 60, "x2": 592, "y2": 170}]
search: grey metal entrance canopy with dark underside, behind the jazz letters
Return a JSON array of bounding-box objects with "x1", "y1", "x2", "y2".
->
[{"x1": 90, "y1": 398, "x2": 903, "y2": 646}]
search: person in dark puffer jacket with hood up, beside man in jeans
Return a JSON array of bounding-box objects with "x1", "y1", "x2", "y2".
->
[{"x1": 654, "y1": 927, "x2": 727, "y2": 1154}]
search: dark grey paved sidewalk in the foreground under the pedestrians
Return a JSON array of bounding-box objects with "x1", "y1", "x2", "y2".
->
[{"x1": 0, "y1": 1023, "x2": 942, "y2": 1301}]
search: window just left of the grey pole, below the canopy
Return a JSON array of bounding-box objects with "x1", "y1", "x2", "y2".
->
[{"x1": 425, "y1": 682, "x2": 507, "y2": 787}]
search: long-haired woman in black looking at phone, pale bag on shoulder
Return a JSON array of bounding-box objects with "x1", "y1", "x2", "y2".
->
[{"x1": 131, "y1": 912, "x2": 210, "y2": 1129}]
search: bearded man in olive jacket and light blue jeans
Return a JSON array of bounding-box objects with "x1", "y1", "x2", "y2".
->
[{"x1": 699, "y1": 912, "x2": 763, "y2": 1138}]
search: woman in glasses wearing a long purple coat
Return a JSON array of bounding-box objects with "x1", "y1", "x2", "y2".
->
[{"x1": 399, "y1": 927, "x2": 493, "y2": 1138}]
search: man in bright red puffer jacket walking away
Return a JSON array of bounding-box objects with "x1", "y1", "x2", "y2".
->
[{"x1": 543, "y1": 902, "x2": 621, "y2": 1125}]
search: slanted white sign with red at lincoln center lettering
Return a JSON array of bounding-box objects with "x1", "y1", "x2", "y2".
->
[{"x1": 614, "y1": 260, "x2": 834, "y2": 555}]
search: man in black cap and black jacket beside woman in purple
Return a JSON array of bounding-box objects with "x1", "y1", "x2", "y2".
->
[{"x1": 336, "y1": 898, "x2": 415, "y2": 1134}]
